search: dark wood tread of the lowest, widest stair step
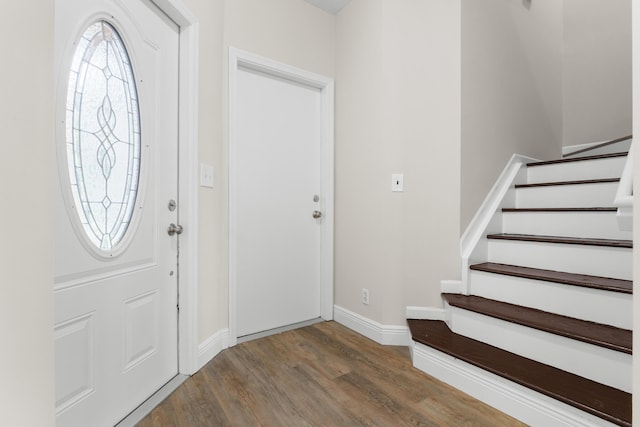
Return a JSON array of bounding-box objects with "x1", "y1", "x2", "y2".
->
[{"x1": 407, "y1": 319, "x2": 631, "y2": 427}]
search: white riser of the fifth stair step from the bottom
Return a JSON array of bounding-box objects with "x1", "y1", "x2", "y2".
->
[{"x1": 502, "y1": 212, "x2": 633, "y2": 240}]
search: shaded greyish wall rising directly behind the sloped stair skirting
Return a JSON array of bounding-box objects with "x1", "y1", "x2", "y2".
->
[{"x1": 461, "y1": 0, "x2": 562, "y2": 231}]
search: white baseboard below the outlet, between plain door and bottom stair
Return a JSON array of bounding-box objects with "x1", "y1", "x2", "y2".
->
[{"x1": 333, "y1": 305, "x2": 411, "y2": 346}]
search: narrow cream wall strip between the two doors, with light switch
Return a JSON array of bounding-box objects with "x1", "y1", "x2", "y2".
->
[{"x1": 183, "y1": 0, "x2": 228, "y2": 342}]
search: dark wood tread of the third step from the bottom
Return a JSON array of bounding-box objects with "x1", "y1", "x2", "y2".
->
[{"x1": 469, "y1": 262, "x2": 633, "y2": 294}]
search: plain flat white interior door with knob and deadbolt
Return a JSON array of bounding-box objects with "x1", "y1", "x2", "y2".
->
[{"x1": 230, "y1": 55, "x2": 331, "y2": 337}]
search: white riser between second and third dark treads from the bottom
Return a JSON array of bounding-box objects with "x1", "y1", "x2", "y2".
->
[{"x1": 469, "y1": 270, "x2": 633, "y2": 329}]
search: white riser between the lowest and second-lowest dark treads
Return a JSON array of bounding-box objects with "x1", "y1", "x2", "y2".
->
[{"x1": 451, "y1": 307, "x2": 633, "y2": 393}]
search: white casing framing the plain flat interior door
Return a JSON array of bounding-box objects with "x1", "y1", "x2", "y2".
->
[{"x1": 229, "y1": 47, "x2": 334, "y2": 346}]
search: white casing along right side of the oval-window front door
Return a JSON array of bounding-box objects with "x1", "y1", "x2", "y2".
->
[{"x1": 152, "y1": 0, "x2": 199, "y2": 375}]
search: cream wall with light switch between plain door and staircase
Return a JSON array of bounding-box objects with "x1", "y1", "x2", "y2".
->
[{"x1": 335, "y1": 0, "x2": 460, "y2": 325}]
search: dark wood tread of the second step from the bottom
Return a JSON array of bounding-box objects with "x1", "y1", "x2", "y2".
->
[{"x1": 442, "y1": 294, "x2": 632, "y2": 354}]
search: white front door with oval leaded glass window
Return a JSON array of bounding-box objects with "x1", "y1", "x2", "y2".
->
[{"x1": 52, "y1": 0, "x2": 178, "y2": 426}]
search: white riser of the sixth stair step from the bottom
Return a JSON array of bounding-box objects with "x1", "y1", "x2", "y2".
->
[{"x1": 516, "y1": 182, "x2": 618, "y2": 208}]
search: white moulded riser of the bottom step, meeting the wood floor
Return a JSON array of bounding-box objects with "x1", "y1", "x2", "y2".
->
[{"x1": 411, "y1": 342, "x2": 614, "y2": 427}]
